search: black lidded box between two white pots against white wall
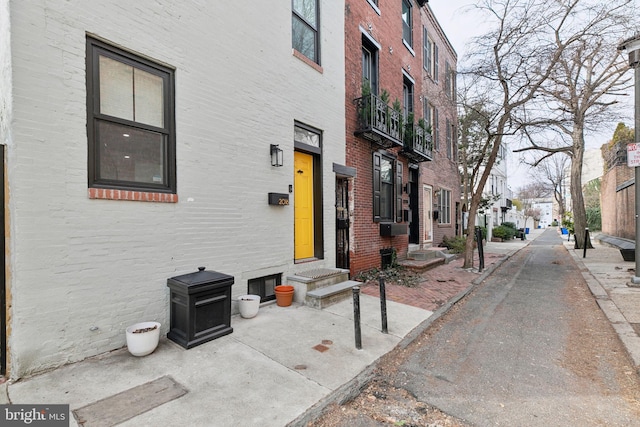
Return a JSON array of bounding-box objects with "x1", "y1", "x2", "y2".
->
[{"x1": 167, "y1": 267, "x2": 234, "y2": 348}]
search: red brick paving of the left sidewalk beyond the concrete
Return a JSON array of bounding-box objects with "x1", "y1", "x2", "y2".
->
[{"x1": 361, "y1": 252, "x2": 506, "y2": 311}]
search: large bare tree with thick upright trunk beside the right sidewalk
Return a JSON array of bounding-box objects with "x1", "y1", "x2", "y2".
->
[{"x1": 514, "y1": 0, "x2": 634, "y2": 248}]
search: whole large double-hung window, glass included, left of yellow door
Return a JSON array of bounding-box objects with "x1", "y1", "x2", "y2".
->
[{"x1": 87, "y1": 38, "x2": 176, "y2": 193}]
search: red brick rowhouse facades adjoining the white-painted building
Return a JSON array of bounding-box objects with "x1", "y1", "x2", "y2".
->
[{"x1": 345, "y1": 0, "x2": 461, "y2": 275}]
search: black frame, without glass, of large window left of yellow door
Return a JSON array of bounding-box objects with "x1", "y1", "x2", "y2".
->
[{"x1": 86, "y1": 36, "x2": 177, "y2": 194}]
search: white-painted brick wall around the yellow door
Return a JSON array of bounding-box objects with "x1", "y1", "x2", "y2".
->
[{"x1": 6, "y1": 0, "x2": 345, "y2": 378}]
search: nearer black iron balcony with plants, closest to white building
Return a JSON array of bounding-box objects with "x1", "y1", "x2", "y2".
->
[{"x1": 354, "y1": 94, "x2": 403, "y2": 148}]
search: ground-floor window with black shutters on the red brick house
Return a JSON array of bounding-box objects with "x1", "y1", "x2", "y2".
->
[{"x1": 373, "y1": 151, "x2": 403, "y2": 222}]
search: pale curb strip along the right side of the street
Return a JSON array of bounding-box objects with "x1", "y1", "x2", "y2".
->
[{"x1": 563, "y1": 245, "x2": 640, "y2": 375}]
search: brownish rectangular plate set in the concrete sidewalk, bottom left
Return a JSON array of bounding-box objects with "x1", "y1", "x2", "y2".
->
[{"x1": 73, "y1": 376, "x2": 187, "y2": 427}]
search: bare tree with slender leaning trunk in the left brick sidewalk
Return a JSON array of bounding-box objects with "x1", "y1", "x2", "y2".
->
[{"x1": 459, "y1": 0, "x2": 577, "y2": 268}]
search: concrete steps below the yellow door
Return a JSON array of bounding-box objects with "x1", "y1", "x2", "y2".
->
[{"x1": 287, "y1": 268, "x2": 362, "y2": 309}]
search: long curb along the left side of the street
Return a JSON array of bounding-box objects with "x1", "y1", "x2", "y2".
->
[{"x1": 286, "y1": 243, "x2": 529, "y2": 427}]
